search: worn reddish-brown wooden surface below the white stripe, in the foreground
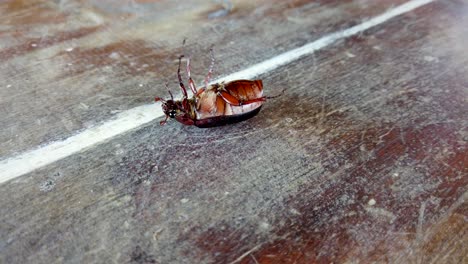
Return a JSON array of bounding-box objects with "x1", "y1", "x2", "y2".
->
[{"x1": 0, "y1": 1, "x2": 468, "y2": 263}]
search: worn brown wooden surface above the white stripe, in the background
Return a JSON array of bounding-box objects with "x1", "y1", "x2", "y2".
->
[{"x1": 0, "y1": 0, "x2": 403, "y2": 157}]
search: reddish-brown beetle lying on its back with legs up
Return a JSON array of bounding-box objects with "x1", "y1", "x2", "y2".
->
[{"x1": 155, "y1": 48, "x2": 276, "y2": 128}]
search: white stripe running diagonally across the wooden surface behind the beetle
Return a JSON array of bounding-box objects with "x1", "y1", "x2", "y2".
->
[{"x1": 0, "y1": 0, "x2": 435, "y2": 183}]
